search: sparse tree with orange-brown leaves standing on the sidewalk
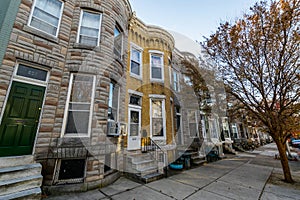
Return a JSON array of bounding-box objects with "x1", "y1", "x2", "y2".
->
[{"x1": 204, "y1": 0, "x2": 300, "y2": 182}]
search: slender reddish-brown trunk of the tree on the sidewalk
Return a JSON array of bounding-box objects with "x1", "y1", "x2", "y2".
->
[{"x1": 274, "y1": 139, "x2": 294, "y2": 183}]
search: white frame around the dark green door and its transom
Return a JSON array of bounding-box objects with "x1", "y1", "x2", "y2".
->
[{"x1": 0, "y1": 61, "x2": 50, "y2": 155}]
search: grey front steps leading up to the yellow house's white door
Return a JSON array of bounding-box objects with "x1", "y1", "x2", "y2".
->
[{"x1": 125, "y1": 152, "x2": 164, "y2": 183}]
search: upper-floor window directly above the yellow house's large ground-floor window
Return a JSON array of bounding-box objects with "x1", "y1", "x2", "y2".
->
[{"x1": 150, "y1": 54, "x2": 164, "y2": 81}]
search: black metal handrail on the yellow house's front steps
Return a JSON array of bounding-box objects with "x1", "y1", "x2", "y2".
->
[{"x1": 142, "y1": 137, "x2": 165, "y2": 163}]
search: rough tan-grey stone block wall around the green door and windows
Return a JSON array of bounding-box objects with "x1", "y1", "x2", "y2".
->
[{"x1": 0, "y1": 0, "x2": 131, "y2": 191}]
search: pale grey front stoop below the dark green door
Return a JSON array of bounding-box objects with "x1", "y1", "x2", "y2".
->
[{"x1": 0, "y1": 156, "x2": 43, "y2": 199}]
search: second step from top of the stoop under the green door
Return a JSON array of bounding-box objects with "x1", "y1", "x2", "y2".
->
[{"x1": 0, "y1": 163, "x2": 42, "y2": 182}]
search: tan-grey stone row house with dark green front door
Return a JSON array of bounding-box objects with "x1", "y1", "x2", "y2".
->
[{"x1": 0, "y1": 0, "x2": 132, "y2": 199}]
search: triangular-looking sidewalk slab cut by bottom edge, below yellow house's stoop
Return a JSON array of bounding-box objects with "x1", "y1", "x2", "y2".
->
[{"x1": 111, "y1": 186, "x2": 174, "y2": 200}]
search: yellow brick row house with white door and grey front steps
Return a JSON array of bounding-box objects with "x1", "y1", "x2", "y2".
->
[{"x1": 124, "y1": 15, "x2": 176, "y2": 181}]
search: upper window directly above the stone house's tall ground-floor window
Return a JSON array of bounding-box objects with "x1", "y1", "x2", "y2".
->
[{"x1": 77, "y1": 10, "x2": 101, "y2": 46}]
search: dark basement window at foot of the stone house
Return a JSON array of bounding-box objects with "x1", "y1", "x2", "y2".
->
[{"x1": 58, "y1": 159, "x2": 86, "y2": 183}]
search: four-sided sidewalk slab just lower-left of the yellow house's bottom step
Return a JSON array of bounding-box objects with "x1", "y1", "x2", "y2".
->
[{"x1": 100, "y1": 177, "x2": 141, "y2": 196}]
